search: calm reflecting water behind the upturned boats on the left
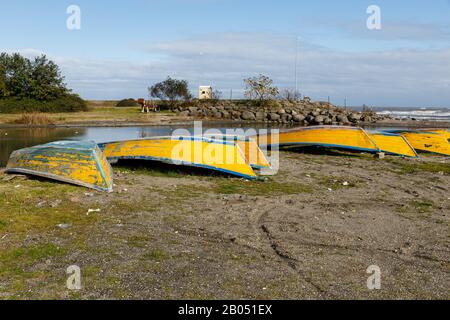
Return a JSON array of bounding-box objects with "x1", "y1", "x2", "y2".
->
[{"x1": 0, "y1": 125, "x2": 274, "y2": 167}]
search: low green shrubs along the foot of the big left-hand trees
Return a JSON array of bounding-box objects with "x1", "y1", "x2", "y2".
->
[{"x1": 0, "y1": 94, "x2": 88, "y2": 113}]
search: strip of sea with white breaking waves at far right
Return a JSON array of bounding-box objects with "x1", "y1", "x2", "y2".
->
[{"x1": 355, "y1": 107, "x2": 450, "y2": 122}]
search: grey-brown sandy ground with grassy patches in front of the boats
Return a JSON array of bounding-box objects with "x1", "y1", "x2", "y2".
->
[{"x1": 0, "y1": 149, "x2": 450, "y2": 299}]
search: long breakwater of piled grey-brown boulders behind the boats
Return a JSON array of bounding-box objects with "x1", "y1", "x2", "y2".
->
[{"x1": 177, "y1": 99, "x2": 386, "y2": 126}]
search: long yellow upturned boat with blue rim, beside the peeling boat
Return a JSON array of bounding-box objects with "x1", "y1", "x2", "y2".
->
[{"x1": 99, "y1": 137, "x2": 257, "y2": 179}]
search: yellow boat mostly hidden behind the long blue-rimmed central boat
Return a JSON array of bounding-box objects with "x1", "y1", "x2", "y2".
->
[{"x1": 206, "y1": 134, "x2": 270, "y2": 169}]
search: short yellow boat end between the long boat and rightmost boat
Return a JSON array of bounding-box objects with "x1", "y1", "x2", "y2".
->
[{"x1": 368, "y1": 132, "x2": 418, "y2": 158}]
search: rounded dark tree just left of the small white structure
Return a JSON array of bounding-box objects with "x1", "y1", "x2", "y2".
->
[{"x1": 148, "y1": 77, "x2": 192, "y2": 105}]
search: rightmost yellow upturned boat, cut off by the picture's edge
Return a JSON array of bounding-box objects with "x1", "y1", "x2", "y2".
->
[{"x1": 387, "y1": 130, "x2": 450, "y2": 156}]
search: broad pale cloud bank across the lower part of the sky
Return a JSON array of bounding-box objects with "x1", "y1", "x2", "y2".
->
[{"x1": 3, "y1": 33, "x2": 450, "y2": 106}]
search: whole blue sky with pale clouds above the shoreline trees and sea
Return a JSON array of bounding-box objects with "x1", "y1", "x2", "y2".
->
[{"x1": 0, "y1": 0, "x2": 450, "y2": 106}]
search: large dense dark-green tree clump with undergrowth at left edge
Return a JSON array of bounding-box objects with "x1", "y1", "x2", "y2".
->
[{"x1": 0, "y1": 53, "x2": 87, "y2": 113}]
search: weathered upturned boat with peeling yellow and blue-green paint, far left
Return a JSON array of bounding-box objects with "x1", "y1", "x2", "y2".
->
[{"x1": 6, "y1": 141, "x2": 113, "y2": 192}]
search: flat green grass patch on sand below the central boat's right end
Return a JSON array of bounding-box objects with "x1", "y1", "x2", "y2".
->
[{"x1": 212, "y1": 179, "x2": 313, "y2": 196}]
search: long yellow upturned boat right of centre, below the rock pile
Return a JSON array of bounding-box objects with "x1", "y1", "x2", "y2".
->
[{"x1": 258, "y1": 126, "x2": 380, "y2": 152}]
